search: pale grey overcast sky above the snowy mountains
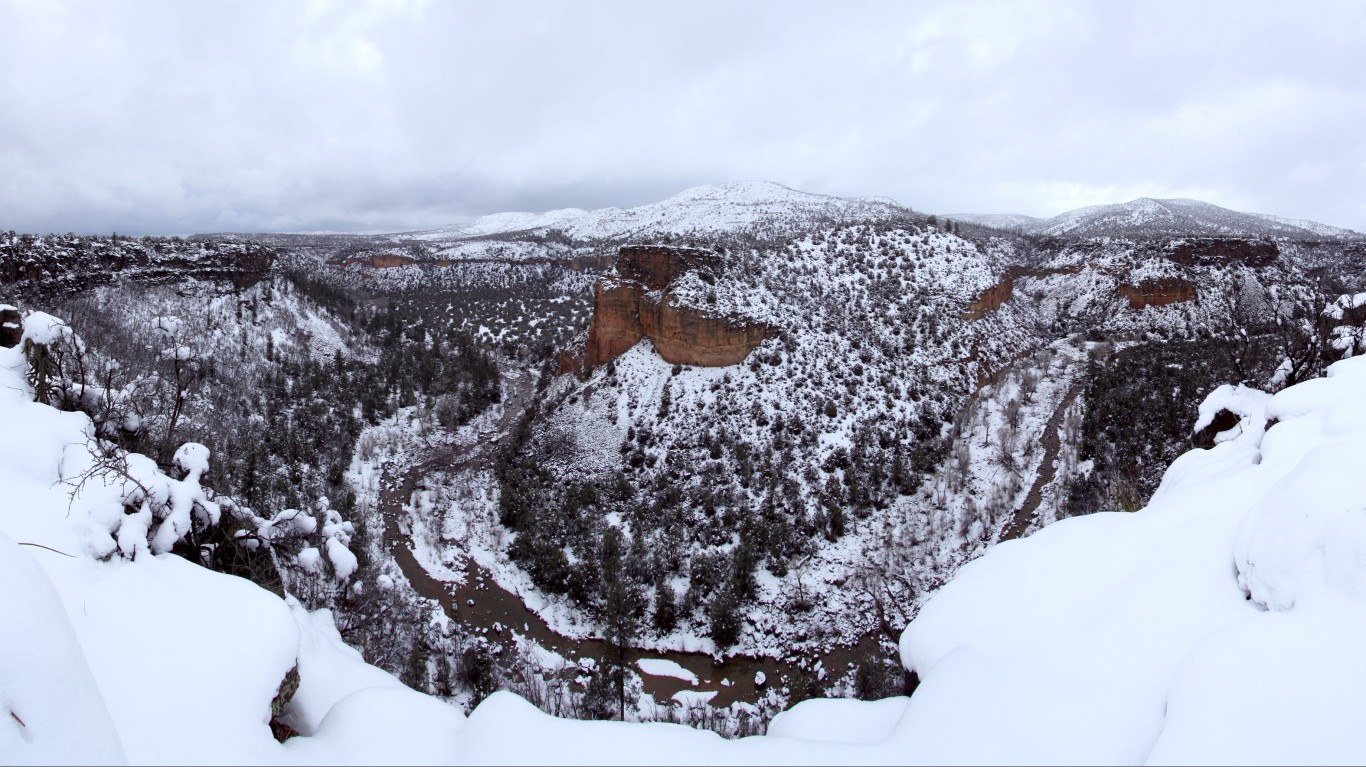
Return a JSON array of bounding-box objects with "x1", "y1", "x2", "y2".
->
[{"x1": 0, "y1": 0, "x2": 1366, "y2": 232}]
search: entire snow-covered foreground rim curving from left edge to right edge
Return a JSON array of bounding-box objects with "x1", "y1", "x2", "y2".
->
[{"x1": 8, "y1": 303, "x2": 1366, "y2": 764}]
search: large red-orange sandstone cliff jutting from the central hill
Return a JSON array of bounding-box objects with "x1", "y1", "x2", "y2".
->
[{"x1": 576, "y1": 246, "x2": 769, "y2": 371}]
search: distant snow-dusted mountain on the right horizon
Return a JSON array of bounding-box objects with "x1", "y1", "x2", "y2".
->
[{"x1": 949, "y1": 197, "x2": 1363, "y2": 239}]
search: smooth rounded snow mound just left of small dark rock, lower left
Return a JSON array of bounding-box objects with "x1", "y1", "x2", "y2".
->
[{"x1": 55, "y1": 546, "x2": 299, "y2": 764}]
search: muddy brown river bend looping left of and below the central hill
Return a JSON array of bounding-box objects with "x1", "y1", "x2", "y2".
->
[{"x1": 380, "y1": 375, "x2": 878, "y2": 707}]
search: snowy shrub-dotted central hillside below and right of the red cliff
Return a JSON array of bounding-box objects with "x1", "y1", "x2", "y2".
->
[{"x1": 486, "y1": 226, "x2": 1038, "y2": 656}]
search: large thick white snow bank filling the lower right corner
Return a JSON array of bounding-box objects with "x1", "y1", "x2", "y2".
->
[{"x1": 892, "y1": 360, "x2": 1366, "y2": 763}]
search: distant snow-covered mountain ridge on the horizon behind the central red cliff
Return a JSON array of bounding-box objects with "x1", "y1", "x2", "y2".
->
[{"x1": 426, "y1": 182, "x2": 908, "y2": 239}]
